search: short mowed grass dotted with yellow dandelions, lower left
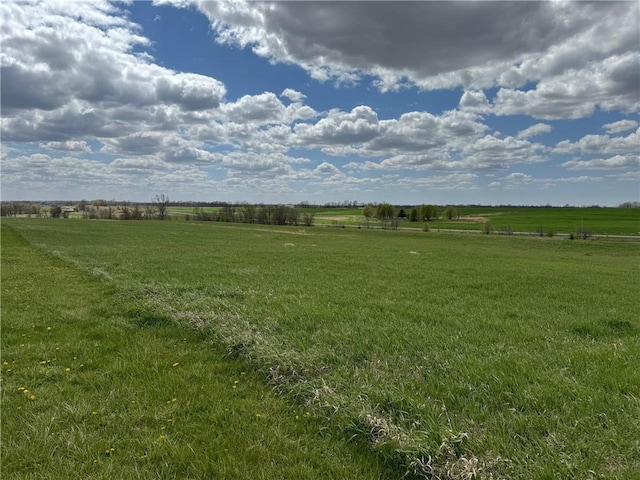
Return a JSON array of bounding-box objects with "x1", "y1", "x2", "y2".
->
[{"x1": 0, "y1": 225, "x2": 388, "y2": 480}]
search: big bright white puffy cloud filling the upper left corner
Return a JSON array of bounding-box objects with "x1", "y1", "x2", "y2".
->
[{"x1": 0, "y1": 2, "x2": 226, "y2": 142}]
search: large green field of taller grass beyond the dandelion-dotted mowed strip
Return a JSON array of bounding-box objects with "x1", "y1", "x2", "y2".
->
[{"x1": 3, "y1": 219, "x2": 640, "y2": 479}]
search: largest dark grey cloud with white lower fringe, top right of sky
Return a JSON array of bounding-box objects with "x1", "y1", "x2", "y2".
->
[{"x1": 172, "y1": 1, "x2": 639, "y2": 96}]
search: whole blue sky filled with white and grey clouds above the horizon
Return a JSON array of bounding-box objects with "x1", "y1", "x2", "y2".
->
[{"x1": 0, "y1": 0, "x2": 640, "y2": 205}]
